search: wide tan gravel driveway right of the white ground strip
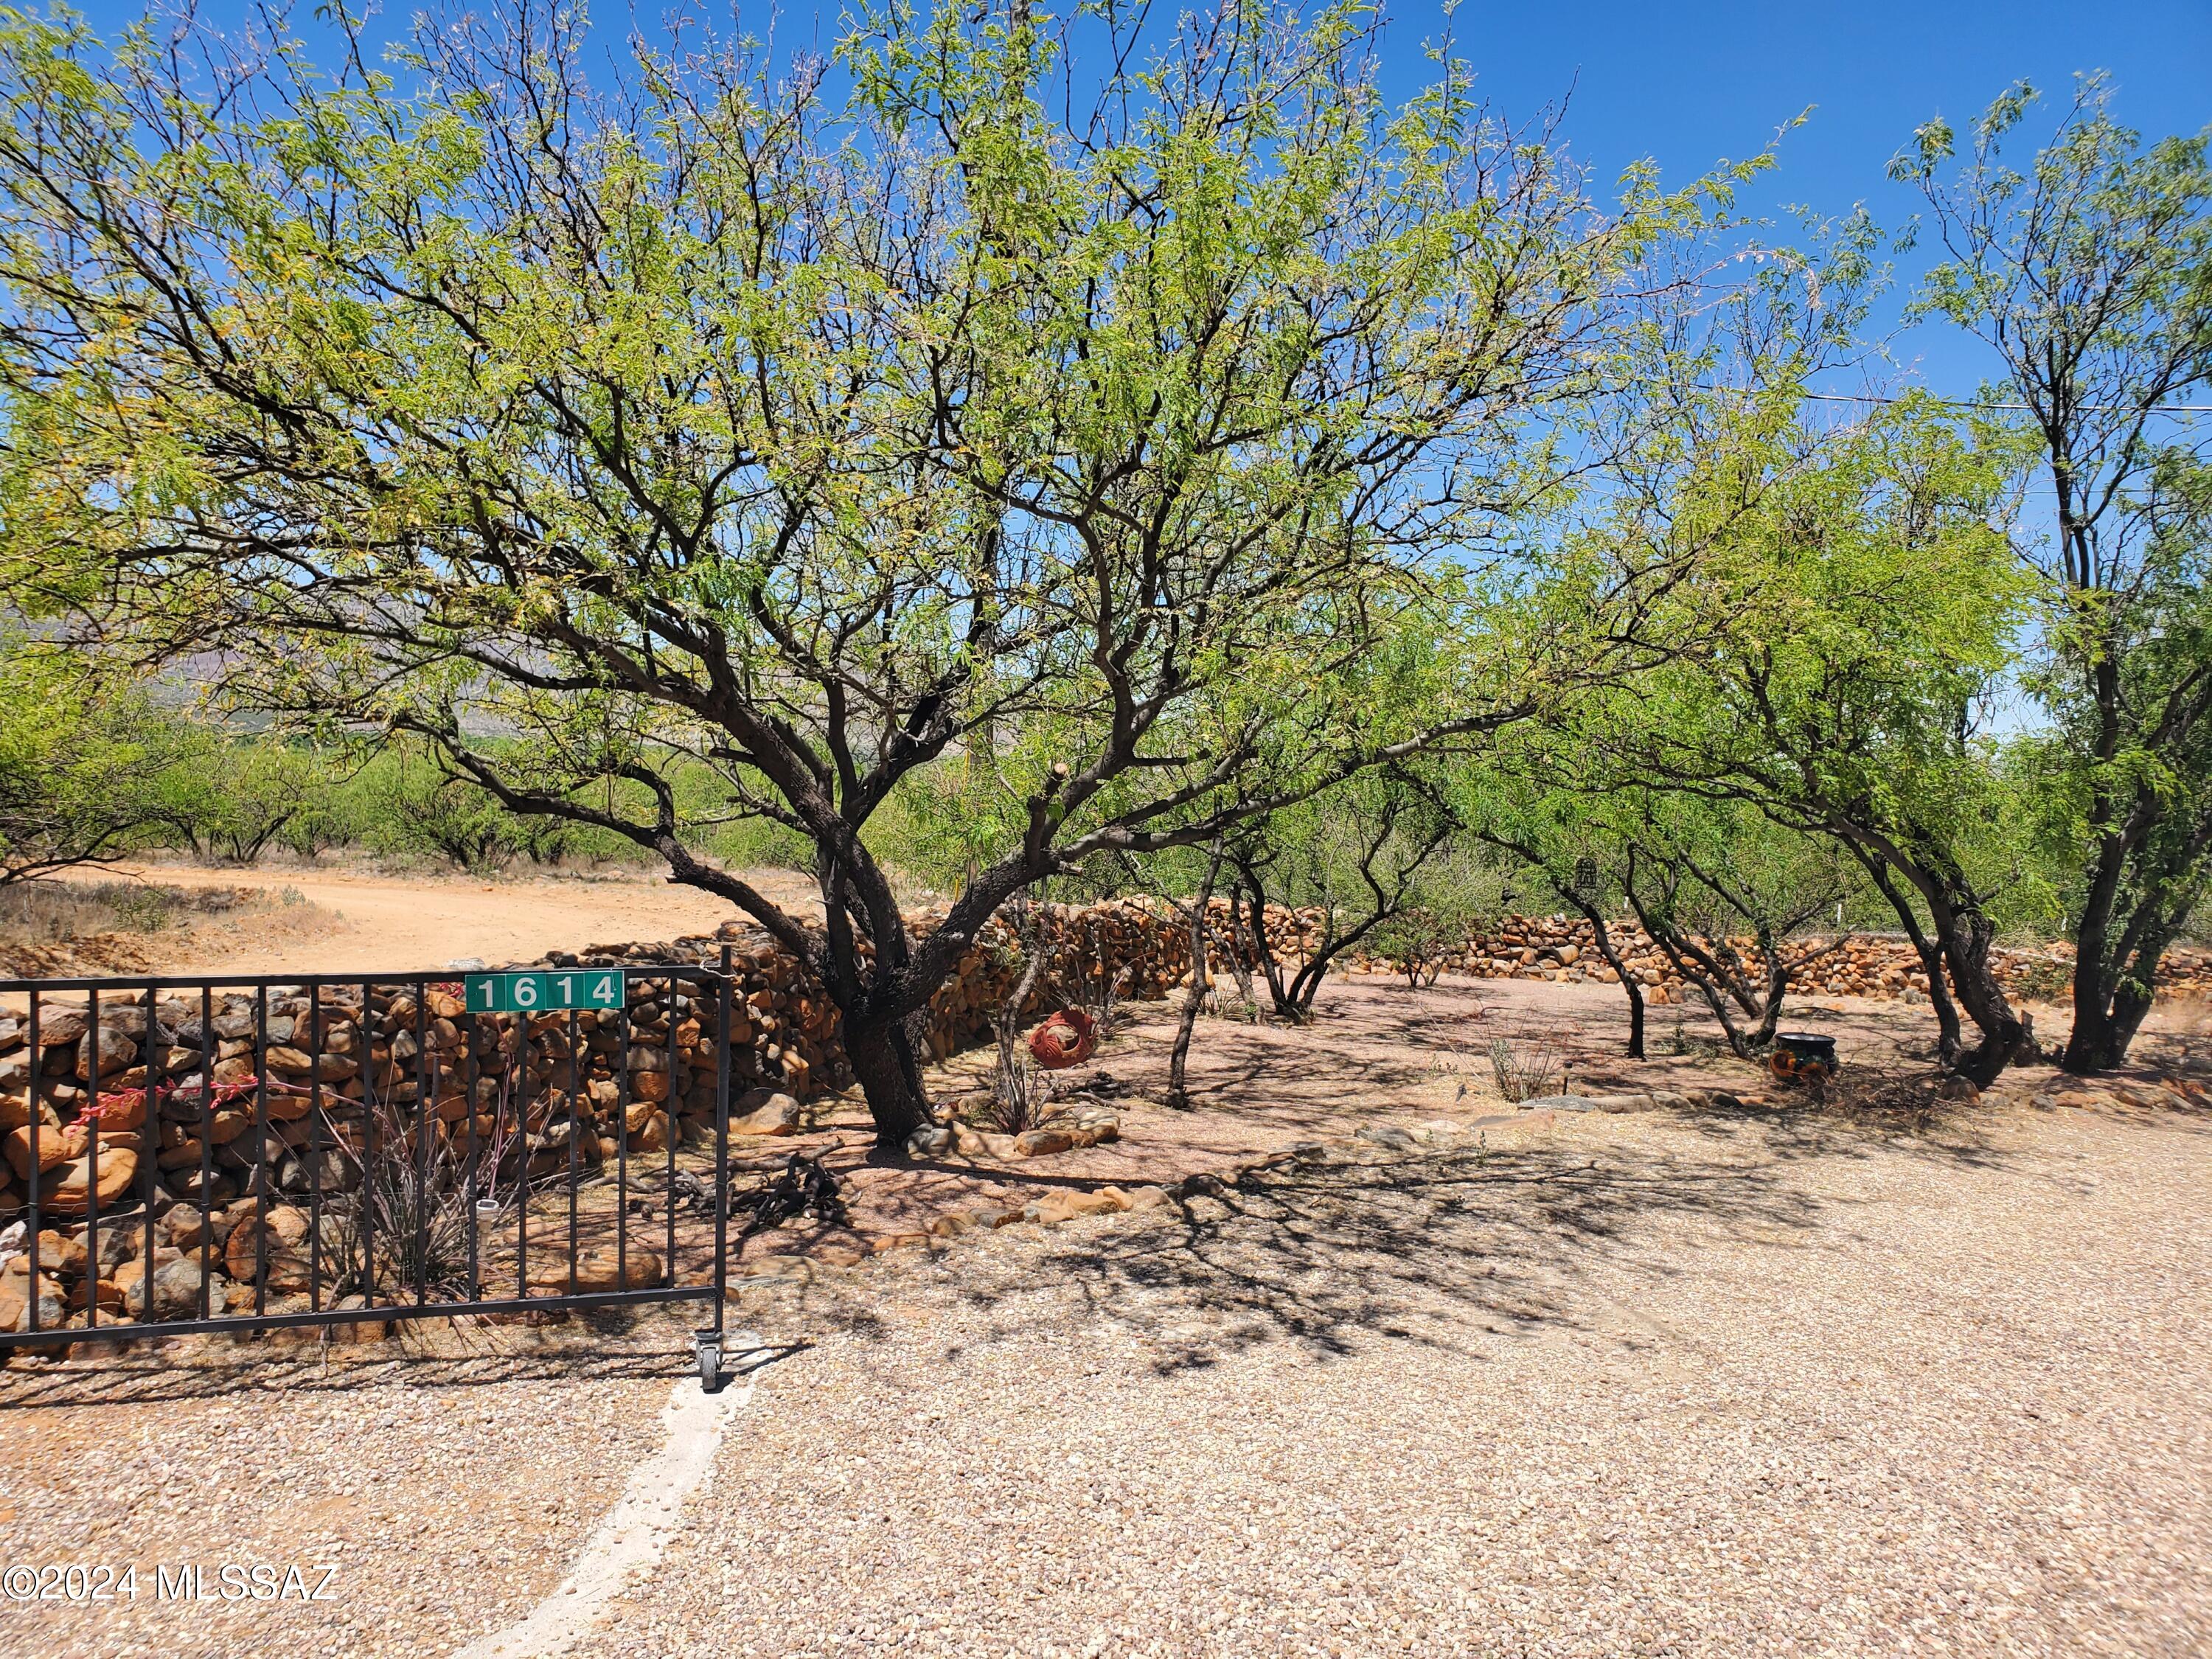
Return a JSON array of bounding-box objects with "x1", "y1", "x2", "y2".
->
[{"x1": 591, "y1": 1108, "x2": 2212, "y2": 1659}]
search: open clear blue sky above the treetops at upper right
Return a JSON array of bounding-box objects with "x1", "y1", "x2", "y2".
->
[{"x1": 1391, "y1": 0, "x2": 2212, "y2": 396}]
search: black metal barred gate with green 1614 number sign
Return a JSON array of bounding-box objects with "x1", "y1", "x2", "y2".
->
[{"x1": 0, "y1": 951, "x2": 732, "y2": 1385}]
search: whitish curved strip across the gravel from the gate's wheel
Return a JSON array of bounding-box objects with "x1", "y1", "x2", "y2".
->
[{"x1": 453, "y1": 1332, "x2": 759, "y2": 1659}]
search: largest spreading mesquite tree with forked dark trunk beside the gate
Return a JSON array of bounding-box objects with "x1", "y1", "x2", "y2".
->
[{"x1": 0, "y1": 4, "x2": 1697, "y2": 1146}]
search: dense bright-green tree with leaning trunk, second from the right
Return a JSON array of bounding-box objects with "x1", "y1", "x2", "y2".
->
[{"x1": 1586, "y1": 403, "x2": 2031, "y2": 1088}]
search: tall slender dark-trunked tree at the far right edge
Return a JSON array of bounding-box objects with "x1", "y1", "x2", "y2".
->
[{"x1": 1893, "y1": 80, "x2": 2212, "y2": 1071}]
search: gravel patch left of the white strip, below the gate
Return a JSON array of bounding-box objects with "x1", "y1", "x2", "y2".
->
[{"x1": 0, "y1": 1325, "x2": 690, "y2": 1659}]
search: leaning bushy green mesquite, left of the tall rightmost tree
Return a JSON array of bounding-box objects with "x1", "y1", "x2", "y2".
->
[{"x1": 1557, "y1": 279, "x2": 2033, "y2": 1084}]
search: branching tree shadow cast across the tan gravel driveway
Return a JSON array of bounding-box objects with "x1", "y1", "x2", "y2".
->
[{"x1": 962, "y1": 1150, "x2": 1823, "y2": 1371}]
